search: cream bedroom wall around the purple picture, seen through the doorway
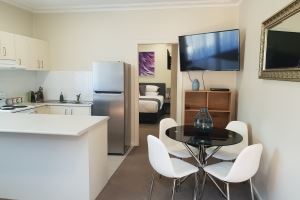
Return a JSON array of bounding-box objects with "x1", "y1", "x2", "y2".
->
[{"x1": 138, "y1": 44, "x2": 171, "y2": 88}]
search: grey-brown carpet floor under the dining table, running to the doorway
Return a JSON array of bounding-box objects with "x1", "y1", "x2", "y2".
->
[{"x1": 97, "y1": 119, "x2": 251, "y2": 200}]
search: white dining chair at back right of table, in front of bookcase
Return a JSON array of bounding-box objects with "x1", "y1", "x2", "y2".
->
[{"x1": 206, "y1": 121, "x2": 248, "y2": 161}]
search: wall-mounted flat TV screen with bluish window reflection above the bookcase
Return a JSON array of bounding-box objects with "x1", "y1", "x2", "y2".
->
[{"x1": 179, "y1": 29, "x2": 240, "y2": 71}]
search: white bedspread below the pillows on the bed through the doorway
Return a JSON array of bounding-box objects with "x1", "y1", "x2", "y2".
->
[{"x1": 139, "y1": 95, "x2": 164, "y2": 113}]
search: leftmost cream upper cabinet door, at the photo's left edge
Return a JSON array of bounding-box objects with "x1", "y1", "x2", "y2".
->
[{"x1": 0, "y1": 31, "x2": 16, "y2": 60}]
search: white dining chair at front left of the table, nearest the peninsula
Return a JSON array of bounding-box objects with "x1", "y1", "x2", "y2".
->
[{"x1": 147, "y1": 135, "x2": 199, "y2": 200}]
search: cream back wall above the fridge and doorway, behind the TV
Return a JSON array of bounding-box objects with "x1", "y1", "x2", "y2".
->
[{"x1": 34, "y1": 6, "x2": 238, "y2": 144}]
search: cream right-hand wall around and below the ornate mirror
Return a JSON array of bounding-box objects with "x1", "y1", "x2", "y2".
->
[{"x1": 237, "y1": 0, "x2": 300, "y2": 200}]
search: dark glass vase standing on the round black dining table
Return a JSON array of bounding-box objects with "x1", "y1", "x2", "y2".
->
[{"x1": 194, "y1": 107, "x2": 214, "y2": 132}]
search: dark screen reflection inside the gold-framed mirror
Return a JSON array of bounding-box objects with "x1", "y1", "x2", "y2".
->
[{"x1": 266, "y1": 30, "x2": 300, "y2": 69}]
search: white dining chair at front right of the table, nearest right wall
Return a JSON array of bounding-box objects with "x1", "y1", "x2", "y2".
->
[{"x1": 201, "y1": 144, "x2": 263, "y2": 200}]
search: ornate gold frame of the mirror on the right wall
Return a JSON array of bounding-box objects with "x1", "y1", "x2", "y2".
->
[{"x1": 258, "y1": 0, "x2": 300, "y2": 81}]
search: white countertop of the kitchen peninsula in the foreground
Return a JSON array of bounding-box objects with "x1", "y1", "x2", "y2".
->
[{"x1": 0, "y1": 113, "x2": 109, "y2": 136}]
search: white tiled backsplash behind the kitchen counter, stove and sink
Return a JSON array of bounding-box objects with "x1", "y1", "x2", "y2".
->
[{"x1": 0, "y1": 70, "x2": 92, "y2": 101}]
